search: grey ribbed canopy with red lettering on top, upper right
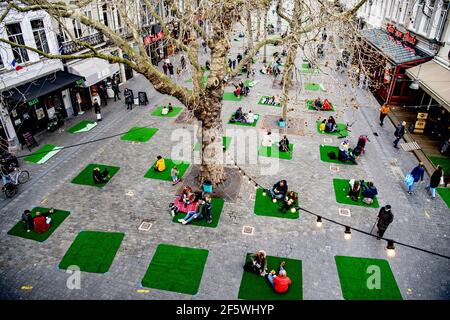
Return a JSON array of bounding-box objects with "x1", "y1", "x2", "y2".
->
[{"x1": 361, "y1": 29, "x2": 432, "y2": 65}]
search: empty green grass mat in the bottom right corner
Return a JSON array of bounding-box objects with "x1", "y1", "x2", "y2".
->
[{"x1": 335, "y1": 256, "x2": 402, "y2": 300}]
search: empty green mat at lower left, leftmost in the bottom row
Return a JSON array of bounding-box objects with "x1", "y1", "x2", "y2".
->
[{"x1": 59, "y1": 231, "x2": 125, "y2": 273}]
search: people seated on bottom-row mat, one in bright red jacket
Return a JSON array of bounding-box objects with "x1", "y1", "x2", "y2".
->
[{"x1": 244, "y1": 250, "x2": 292, "y2": 293}]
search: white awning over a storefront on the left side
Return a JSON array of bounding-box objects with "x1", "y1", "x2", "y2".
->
[{"x1": 69, "y1": 58, "x2": 120, "y2": 87}]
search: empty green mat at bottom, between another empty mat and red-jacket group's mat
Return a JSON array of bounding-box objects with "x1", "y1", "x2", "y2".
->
[{"x1": 141, "y1": 244, "x2": 208, "y2": 295}]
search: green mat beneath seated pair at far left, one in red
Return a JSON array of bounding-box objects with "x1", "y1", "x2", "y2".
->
[{"x1": 8, "y1": 207, "x2": 70, "y2": 242}]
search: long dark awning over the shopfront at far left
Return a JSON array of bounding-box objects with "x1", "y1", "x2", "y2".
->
[{"x1": 2, "y1": 71, "x2": 84, "y2": 103}]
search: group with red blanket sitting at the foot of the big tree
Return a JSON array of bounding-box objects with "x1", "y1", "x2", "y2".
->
[{"x1": 169, "y1": 186, "x2": 213, "y2": 225}]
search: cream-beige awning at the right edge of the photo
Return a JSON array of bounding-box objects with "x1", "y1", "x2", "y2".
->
[{"x1": 406, "y1": 60, "x2": 450, "y2": 112}]
